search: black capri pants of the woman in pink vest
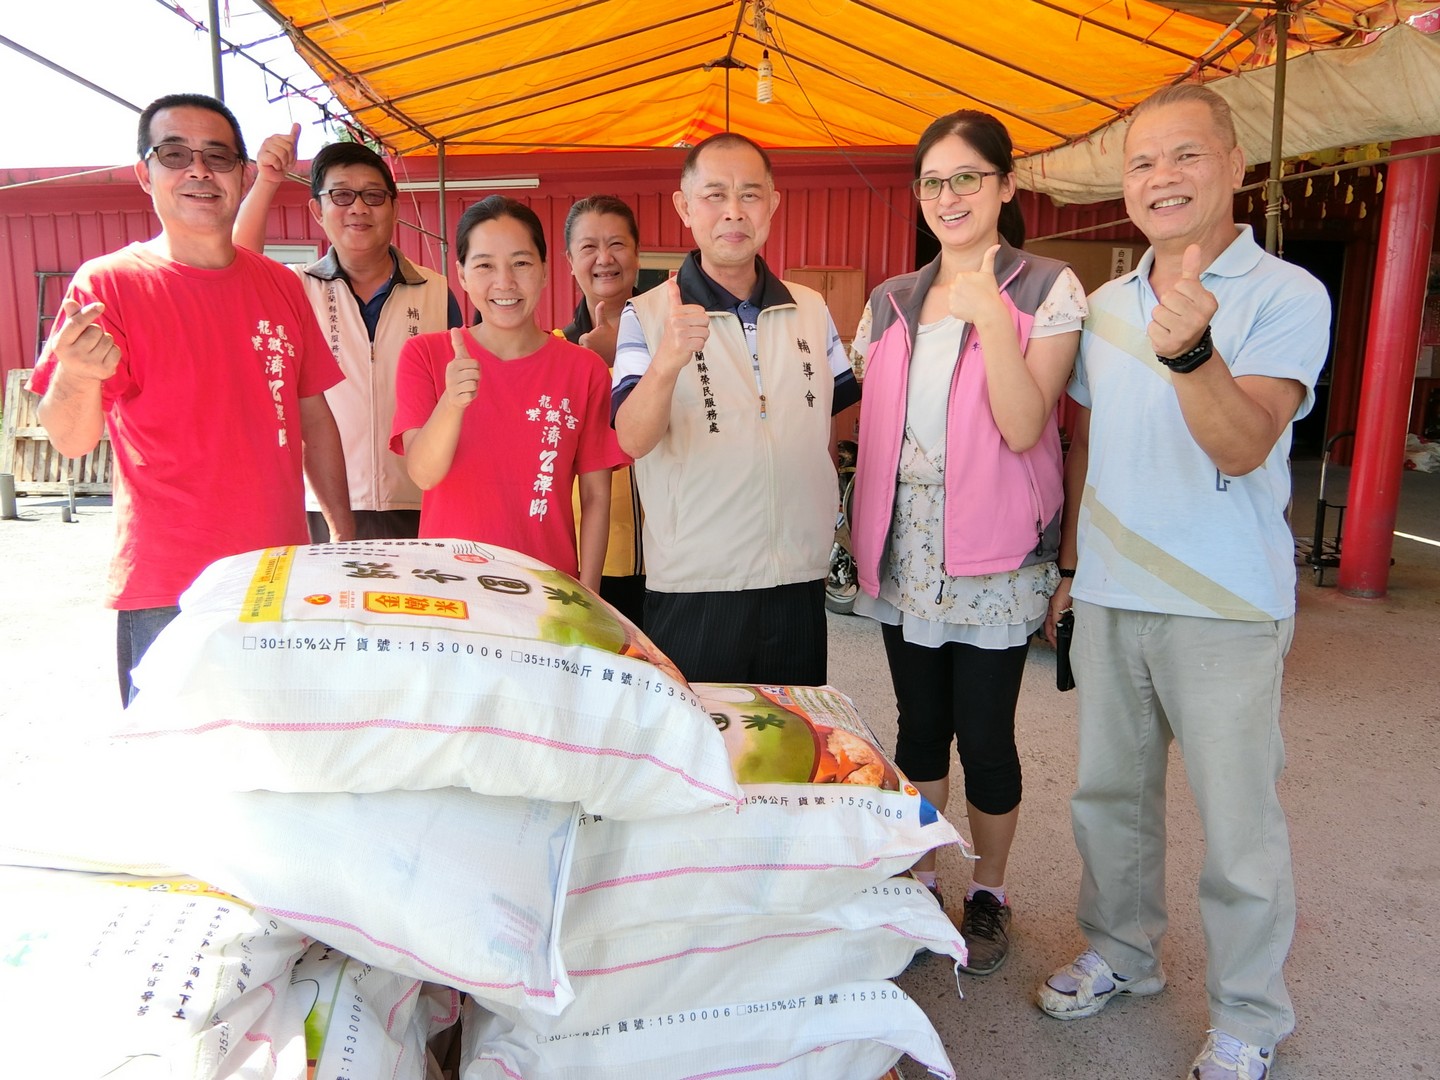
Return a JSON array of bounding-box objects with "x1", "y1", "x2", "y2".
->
[{"x1": 880, "y1": 624, "x2": 1030, "y2": 815}]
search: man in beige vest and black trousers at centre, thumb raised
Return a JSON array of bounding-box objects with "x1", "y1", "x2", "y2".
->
[{"x1": 612, "y1": 132, "x2": 860, "y2": 685}]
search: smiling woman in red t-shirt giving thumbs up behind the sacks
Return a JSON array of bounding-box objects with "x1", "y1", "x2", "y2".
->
[{"x1": 390, "y1": 194, "x2": 629, "y2": 590}]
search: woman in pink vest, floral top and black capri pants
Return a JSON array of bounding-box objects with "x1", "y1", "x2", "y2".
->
[{"x1": 851, "y1": 109, "x2": 1086, "y2": 975}]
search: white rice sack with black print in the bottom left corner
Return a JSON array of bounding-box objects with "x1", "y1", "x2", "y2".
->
[{"x1": 0, "y1": 867, "x2": 308, "y2": 1077}]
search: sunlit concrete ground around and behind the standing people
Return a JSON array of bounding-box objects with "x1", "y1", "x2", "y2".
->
[{"x1": 0, "y1": 462, "x2": 1440, "y2": 1080}]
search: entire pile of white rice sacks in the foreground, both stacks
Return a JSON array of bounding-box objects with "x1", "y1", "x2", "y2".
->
[{"x1": 0, "y1": 540, "x2": 963, "y2": 1080}]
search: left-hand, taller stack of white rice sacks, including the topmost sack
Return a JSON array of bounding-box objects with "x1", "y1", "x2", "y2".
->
[{"x1": 0, "y1": 540, "x2": 740, "y2": 1080}]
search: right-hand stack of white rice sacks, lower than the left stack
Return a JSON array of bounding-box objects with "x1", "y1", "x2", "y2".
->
[{"x1": 462, "y1": 684, "x2": 965, "y2": 1080}]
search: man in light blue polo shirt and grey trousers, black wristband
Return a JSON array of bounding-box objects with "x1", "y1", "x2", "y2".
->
[{"x1": 1038, "y1": 85, "x2": 1329, "y2": 1080}]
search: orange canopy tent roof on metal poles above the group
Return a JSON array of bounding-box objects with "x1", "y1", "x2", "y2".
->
[{"x1": 259, "y1": 0, "x2": 1440, "y2": 200}]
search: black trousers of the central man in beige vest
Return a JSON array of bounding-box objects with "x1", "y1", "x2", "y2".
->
[{"x1": 645, "y1": 579, "x2": 825, "y2": 687}]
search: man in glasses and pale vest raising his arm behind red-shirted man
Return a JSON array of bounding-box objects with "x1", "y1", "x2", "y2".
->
[{"x1": 235, "y1": 133, "x2": 462, "y2": 544}]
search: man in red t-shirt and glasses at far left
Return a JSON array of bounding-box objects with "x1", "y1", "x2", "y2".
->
[{"x1": 30, "y1": 94, "x2": 353, "y2": 703}]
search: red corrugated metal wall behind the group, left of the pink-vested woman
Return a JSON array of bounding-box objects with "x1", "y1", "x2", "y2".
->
[{"x1": 0, "y1": 151, "x2": 914, "y2": 370}]
